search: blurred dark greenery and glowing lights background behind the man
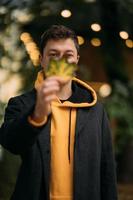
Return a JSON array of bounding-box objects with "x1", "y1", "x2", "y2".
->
[{"x1": 0, "y1": 0, "x2": 133, "y2": 200}]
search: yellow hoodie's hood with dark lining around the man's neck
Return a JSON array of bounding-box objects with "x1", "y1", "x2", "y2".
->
[{"x1": 35, "y1": 71, "x2": 97, "y2": 108}]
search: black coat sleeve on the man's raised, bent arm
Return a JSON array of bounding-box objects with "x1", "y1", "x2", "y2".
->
[{"x1": 0, "y1": 97, "x2": 42, "y2": 154}]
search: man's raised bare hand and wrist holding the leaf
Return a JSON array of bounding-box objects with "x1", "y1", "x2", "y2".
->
[{"x1": 32, "y1": 76, "x2": 70, "y2": 122}]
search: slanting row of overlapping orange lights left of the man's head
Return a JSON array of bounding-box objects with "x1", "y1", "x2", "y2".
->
[{"x1": 20, "y1": 32, "x2": 40, "y2": 66}]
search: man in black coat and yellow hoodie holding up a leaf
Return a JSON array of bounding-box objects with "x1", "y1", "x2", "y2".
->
[{"x1": 0, "y1": 25, "x2": 117, "y2": 200}]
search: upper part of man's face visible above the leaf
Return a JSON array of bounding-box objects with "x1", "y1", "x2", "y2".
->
[{"x1": 40, "y1": 38, "x2": 79, "y2": 69}]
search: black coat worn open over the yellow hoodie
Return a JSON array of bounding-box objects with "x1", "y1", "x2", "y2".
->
[{"x1": 0, "y1": 90, "x2": 117, "y2": 200}]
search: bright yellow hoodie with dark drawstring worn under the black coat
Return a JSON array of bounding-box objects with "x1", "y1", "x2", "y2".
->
[{"x1": 29, "y1": 72, "x2": 97, "y2": 200}]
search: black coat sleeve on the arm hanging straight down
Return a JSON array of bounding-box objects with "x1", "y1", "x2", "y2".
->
[{"x1": 101, "y1": 107, "x2": 117, "y2": 200}]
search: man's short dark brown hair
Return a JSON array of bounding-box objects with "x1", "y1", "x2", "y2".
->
[{"x1": 40, "y1": 25, "x2": 79, "y2": 54}]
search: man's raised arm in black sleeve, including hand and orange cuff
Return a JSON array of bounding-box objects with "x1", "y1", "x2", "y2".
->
[{"x1": 0, "y1": 76, "x2": 69, "y2": 154}]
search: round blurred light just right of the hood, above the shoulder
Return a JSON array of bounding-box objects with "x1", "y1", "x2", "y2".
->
[{"x1": 99, "y1": 83, "x2": 112, "y2": 97}]
